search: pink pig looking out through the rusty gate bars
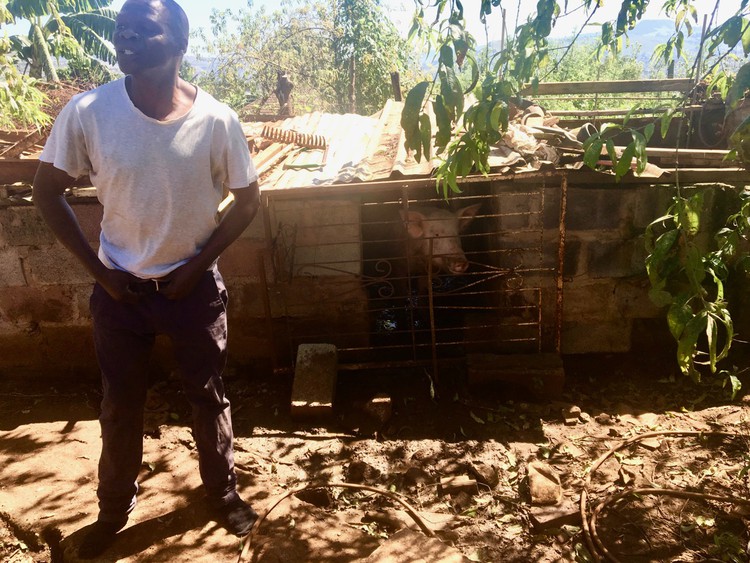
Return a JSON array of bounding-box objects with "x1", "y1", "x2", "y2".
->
[{"x1": 401, "y1": 204, "x2": 481, "y2": 275}]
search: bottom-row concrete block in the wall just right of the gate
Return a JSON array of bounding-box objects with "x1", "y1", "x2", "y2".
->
[{"x1": 562, "y1": 319, "x2": 632, "y2": 354}]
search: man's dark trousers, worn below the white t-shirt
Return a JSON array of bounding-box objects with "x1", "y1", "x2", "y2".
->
[{"x1": 90, "y1": 268, "x2": 237, "y2": 523}]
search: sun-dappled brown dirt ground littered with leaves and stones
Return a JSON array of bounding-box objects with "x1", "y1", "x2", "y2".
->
[{"x1": 0, "y1": 356, "x2": 750, "y2": 563}]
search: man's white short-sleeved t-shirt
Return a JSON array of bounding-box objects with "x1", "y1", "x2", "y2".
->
[{"x1": 40, "y1": 78, "x2": 258, "y2": 278}]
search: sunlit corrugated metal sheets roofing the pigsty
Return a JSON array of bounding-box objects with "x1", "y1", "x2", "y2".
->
[{"x1": 244, "y1": 94, "x2": 688, "y2": 187}]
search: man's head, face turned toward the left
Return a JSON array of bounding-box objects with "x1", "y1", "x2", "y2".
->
[{"x1": 113, "y1": 0, "x2": 182, "y2": 75}]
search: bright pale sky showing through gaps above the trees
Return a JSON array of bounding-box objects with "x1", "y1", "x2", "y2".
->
[{"x1": 5, "y1": 0, "x2": 741, "y2": 54}]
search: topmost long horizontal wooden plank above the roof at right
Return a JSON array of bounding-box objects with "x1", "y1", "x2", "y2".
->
[{"x1": 520, "y1": 78, "x2": 695, "y2": 96}]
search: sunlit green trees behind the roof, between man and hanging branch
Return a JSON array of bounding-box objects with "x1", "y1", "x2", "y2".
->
[{"x1": 196, "y1": 0, "x2": 416, "y2": 114}]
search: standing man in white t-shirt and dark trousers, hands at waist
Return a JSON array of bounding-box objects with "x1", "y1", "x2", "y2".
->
[{"x1": 34, "y1": 0, "x2": 260, "y2": 558}]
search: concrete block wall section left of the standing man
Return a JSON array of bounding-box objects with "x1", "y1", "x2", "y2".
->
[{"x1": 0, "y1": 200, "x2": 101, "y2": 376}]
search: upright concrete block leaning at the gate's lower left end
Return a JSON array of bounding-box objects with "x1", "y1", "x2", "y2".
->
[{"x1": 291, "y1": 344, "x2": 338, "y2": 419}]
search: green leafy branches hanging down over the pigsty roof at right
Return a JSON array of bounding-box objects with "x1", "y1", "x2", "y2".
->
[{"x1": 402, "y1": 0, "x2": 750, "y2": 197}]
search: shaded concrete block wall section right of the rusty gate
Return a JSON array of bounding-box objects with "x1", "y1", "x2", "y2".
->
[{"x1": 556, "y1": 184, "x2": 739, "y2": 354}]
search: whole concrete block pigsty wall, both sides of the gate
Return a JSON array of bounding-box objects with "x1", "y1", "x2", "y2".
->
[{"x1": 0, "y1": 184, "x2": 750, "y2": 376}]
